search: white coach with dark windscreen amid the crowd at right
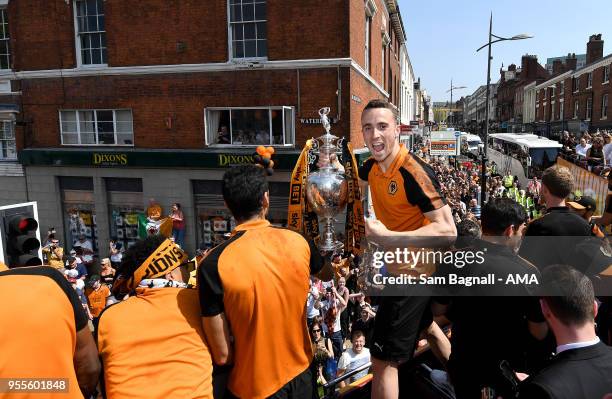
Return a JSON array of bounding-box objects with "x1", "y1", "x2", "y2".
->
[{"x1": 487, "y1": 133, "x2": 562, "y2": 187}]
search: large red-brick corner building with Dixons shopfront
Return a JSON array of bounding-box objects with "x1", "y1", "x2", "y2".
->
[{"x1": 0, "y1": 0, "x2": 405, "y2": 255}]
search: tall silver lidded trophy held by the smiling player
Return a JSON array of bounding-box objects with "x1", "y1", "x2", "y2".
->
[{"x1": 306, "y1": 108, "x2": 348, "y2": 251}]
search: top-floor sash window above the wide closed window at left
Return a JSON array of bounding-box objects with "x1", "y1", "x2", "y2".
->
[{"x1": 74, "y1": 0, "x2": 107, "y2": 65}]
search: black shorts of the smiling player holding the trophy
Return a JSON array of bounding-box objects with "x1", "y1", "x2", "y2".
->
[{"x1": 370, "y1": 296, "x2": 433, "y2": 363}]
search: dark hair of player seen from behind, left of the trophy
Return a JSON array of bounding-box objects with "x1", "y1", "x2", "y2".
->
[{"x1": 223, "y1": 165, "x2": 269, "y2": 220}]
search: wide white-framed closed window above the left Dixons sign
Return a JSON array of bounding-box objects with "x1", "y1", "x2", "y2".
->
[{"x1": 60, "y1": 109, "x2": 134, "y2": 146}]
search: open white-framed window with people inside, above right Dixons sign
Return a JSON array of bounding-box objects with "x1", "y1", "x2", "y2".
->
[{"x1": 206, "y1": 107, "x2": 295, "y2": 146}]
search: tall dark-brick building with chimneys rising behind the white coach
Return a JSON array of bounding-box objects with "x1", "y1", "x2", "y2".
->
[{"x1": 495, "y1": 55, "x2": 548, "y2": 132}]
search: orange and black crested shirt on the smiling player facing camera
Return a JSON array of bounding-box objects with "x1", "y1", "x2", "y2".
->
[{"x1": 359, "y1": 144, "x2": 446, "y2": 231}]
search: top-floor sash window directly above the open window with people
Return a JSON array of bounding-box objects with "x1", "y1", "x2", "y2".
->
[{"x1": 229, "y1": 0, "x2": 268, "y2": 59}]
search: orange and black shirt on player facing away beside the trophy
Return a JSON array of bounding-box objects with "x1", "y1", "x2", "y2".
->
[{"x1": 198, "y1": 220, "x2": 322, "y2": 399}]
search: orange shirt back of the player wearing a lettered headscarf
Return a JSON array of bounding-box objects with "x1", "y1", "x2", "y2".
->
[{"x1": 98, "y1": 287, "x2": 213, "y2": 399}]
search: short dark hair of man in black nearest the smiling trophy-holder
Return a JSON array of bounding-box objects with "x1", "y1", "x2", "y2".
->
[{"x1": 480, "y1": 198, "x2": 527, "y2": 235}]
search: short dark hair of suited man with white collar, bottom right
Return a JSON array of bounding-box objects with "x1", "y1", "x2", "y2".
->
[{"x1": 542, "y1": 265, "x2": 595, "y2": 326}]
